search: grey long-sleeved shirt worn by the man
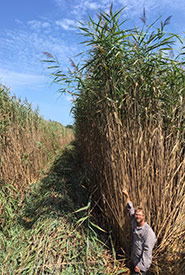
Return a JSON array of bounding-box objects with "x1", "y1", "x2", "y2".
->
[{"x1": 127, "y1": 201, "x2": 156, "y2": 272}]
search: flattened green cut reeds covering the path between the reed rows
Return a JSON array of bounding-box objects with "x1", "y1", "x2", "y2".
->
[{"x1": 0, "y1": 145, "x2": 121, "y2": 275}]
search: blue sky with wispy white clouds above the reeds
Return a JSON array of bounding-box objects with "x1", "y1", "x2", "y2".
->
[{"x1": 0, "y1": 0, "x2": 185, "y2": 125}]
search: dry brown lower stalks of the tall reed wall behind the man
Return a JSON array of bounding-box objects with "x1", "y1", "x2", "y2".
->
[{"x1": 76, "y1": 102, "x2": 185, "y2": 274}]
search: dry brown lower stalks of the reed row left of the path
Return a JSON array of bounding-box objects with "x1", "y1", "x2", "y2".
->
[{"x1": 0, "y1": 105, "x2": 73, "y2": 201}]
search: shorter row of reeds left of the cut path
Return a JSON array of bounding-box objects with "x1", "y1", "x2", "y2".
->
[{"x1": 0, "y1": 85, "x2": 73, "y2": 198}]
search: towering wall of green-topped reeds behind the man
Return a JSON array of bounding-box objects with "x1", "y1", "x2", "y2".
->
[{"x1": 45, "y1": 6, "x2": 185, "y2": 274}]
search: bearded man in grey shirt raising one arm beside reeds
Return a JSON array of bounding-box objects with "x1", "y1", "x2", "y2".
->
[{"x1": 123, "y1": 190, "x2": 156, "y2": 275}]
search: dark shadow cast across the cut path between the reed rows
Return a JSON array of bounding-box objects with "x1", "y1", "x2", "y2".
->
[{"x1": 19, "y1": 142, "x2": 88, "y2": 229}]
